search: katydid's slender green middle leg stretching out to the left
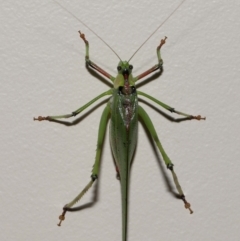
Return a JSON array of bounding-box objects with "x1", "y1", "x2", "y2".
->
[{"x1": 33, "y1": 89, "x2": 112, "y2": 121}]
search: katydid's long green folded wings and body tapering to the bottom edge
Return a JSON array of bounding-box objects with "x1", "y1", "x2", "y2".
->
[{"x1": 109, "y1": 86, "x2": 138, "y2": 241}]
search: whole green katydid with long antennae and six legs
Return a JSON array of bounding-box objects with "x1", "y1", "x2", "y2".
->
[{"x1": 34, "y1": 0, "x2": 205, "y2": 241}]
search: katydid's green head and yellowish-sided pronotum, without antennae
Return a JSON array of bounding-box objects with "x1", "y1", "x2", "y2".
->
[{"x1": 114, "y1": 61, "x2": 135, "y2": 95}]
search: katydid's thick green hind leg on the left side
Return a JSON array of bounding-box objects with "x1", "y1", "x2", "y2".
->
[{"x1": 58, "y1": 104, "x2": 110, "y2": 226}]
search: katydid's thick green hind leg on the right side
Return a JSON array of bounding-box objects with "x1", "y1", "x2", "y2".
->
[{"x1": 138, "y1": 106, "x2": 193, "y2": 213}]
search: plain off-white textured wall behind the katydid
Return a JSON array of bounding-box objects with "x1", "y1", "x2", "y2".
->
[{"x1": 0, "y1": 0, "x2": 240, "y2": 241}]
